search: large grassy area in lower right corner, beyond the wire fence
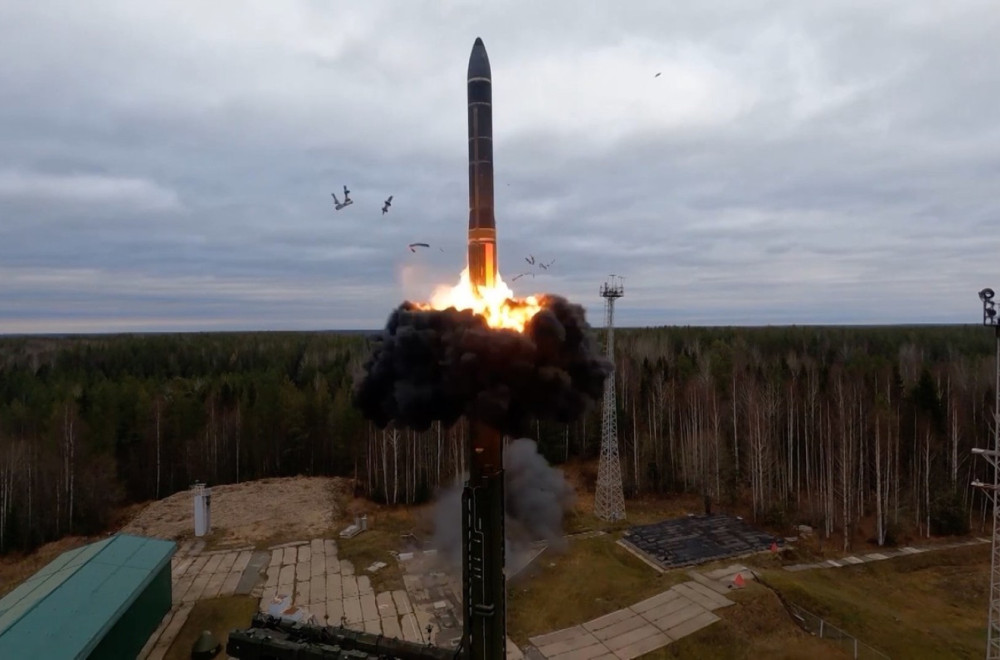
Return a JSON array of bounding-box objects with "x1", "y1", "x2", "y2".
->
[{"x1": 762, "y1": 544, "x2": 990, "y2": 660}]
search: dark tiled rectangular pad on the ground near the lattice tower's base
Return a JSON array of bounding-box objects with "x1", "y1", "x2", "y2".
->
[{"x1": 622, "y1": 514, "x2": 784, "y2": 568}]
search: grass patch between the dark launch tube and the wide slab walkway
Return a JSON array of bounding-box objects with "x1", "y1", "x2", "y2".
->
[{"x1": 507, "y1": 534, "x2": 688, "y2": 644}]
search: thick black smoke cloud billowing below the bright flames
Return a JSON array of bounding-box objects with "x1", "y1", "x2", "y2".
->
[{"x1": 354, "y1": 295, "x2": 613, "y2": 435}]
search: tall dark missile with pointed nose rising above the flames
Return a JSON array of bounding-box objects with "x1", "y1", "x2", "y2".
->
[{"x1": 468, "y1": 38, "x2": 497, "y2": 287}]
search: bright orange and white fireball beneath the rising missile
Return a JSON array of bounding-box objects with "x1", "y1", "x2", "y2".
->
[{"x1": 417, "y1": 268, "x2": 542, "y2": 332}]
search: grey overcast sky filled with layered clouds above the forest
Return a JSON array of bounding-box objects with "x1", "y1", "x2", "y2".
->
[{"x1": 0, "y1": 0, "x2": 1000, "y2": 333}]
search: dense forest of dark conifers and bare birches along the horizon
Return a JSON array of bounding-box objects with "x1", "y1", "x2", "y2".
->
[{"x1": 0, "y1": 326, "x2": 995, "y2": 552}]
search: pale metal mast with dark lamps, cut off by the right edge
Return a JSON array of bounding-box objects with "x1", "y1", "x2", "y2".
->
[{"x1": 972, "y1": 289, "x2": 1000, "y2": 660}]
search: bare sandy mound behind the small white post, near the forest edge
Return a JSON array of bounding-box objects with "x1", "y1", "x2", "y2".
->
[{"x1": 120, "y1": 477, "x2": 350, "y2": 548}]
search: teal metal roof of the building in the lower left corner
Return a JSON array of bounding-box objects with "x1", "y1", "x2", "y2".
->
[{"x1": 0, "y1": 534, "x2": 177, "y2": 658}]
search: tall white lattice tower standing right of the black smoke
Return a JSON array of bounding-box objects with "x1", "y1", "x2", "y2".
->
[{"x1": 594, "y1": 275, "x2": 625, "y2": 521}]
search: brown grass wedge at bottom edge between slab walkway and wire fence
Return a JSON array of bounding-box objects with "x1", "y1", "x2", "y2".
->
[{"x1": 643, "y1": 581, "x2": 849, "y2": 660}]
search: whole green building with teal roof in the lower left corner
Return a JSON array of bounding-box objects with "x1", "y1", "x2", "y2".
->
[{"x1": 0, "y1": 534, "x2": 177, "y2": 660}]
